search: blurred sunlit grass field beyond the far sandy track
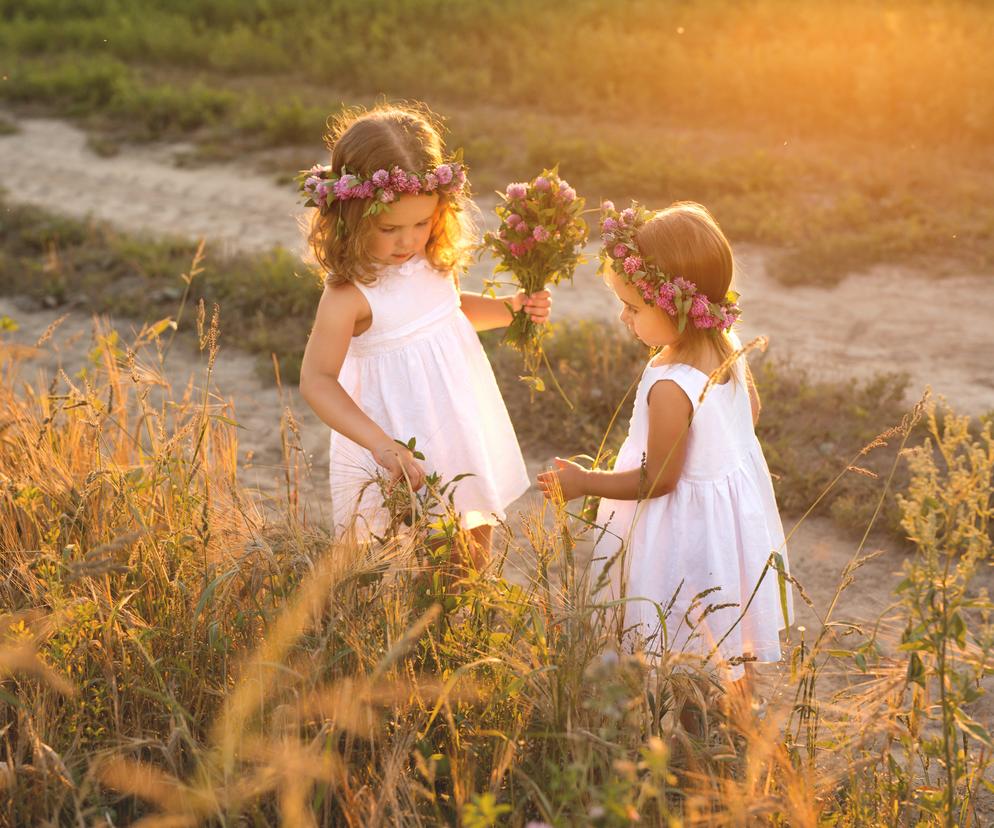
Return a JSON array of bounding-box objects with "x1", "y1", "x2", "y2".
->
[{"x1": 0, "y1": 0, "x2": 994, "y2": 283}]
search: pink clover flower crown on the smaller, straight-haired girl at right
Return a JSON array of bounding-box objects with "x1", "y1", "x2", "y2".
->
[{"x1": 600, "y1": 201, "x2": 742, "y2": 333}]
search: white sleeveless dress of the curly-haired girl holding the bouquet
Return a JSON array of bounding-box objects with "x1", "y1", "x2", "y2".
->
[{"x1": 330, "y1": 255, "x2": 529, "y2": 538}]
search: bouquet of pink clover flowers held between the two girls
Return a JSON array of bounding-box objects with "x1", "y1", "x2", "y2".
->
[{"x1": 483, "y1": 168, "x2": 587, "y2": 391}]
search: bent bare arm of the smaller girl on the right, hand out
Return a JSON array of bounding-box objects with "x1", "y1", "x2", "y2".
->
[{"x1": 538, "y1": 380, "x2": 694, "y2": 501}]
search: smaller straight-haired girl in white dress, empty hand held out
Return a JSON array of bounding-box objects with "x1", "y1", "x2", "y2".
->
[{"x1": 539, "y1": 202, "x2": 792, "y2": 690}]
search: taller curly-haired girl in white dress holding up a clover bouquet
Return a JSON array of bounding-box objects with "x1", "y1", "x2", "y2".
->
[{"x1": 300, "y1": 106, "x2": 551, "y2": 564}]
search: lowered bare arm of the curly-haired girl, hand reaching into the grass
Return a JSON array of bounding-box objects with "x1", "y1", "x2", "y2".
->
[{"x1": 300, "y1": 284, "x2": 425, "y2": 489}]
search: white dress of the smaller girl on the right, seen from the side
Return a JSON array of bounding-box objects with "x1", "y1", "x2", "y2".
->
[{"x1": 590, "y1": 360, "x2": 793, "y2": 680}]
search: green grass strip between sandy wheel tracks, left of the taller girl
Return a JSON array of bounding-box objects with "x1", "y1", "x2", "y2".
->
[{"x1": 0, "y1": 197, "x2": 320, "y2": 381}]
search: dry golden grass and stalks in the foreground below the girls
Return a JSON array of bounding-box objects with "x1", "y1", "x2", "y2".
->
[{"x1": 0, "y1": 296, "x2": 994, "y2": 826}]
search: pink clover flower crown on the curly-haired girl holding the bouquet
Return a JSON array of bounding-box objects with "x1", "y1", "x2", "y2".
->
[{"x1": 296, "y1": 158, "x2": 466, "y2": 216}]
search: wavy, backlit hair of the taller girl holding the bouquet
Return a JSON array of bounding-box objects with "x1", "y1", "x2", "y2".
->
[{"x1": 307, "y1": 104, "x2": 476, "y2": 285}]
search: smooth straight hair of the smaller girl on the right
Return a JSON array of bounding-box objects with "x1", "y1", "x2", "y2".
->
[{"x1": 635, "y1": 201, "x2": 735, "y2": 378}]
